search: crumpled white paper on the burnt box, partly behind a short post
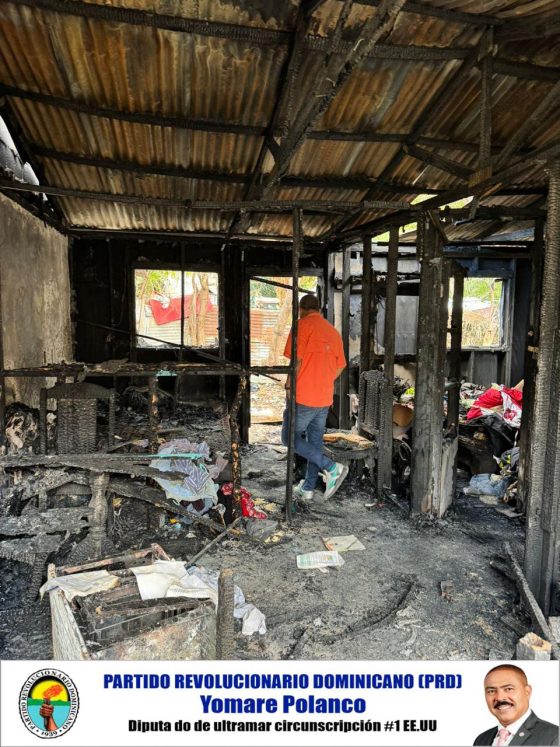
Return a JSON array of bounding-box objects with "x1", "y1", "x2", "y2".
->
[{"x1": 131, "y1": 560, "x2": 266, "y2": 635}]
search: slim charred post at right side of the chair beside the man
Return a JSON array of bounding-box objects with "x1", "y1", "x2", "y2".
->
[{"x1": 377, "y1": 226, "x2": 399, "y2": 496}]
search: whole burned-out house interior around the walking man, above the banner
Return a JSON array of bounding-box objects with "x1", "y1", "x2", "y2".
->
[{"x1": 0, "y1": 0, "x2": 560, "y2": 659}]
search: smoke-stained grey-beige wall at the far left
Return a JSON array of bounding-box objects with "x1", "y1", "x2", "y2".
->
[{"x1": 0, "y1": 194, "x2": 72, "y2": 406}]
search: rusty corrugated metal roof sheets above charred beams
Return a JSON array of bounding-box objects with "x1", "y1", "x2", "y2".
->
[{"x1": 0, "y1": 0, "x2": 560, "y2": 238}]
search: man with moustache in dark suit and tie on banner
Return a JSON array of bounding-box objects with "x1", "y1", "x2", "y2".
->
[{"x1": 474, "y1": 664, "x2": 558, "y2": 747}]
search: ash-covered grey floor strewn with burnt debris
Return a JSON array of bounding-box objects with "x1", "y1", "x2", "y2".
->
[{"x1": 0, "y1": 432, "x2": 530, "y2": 660}]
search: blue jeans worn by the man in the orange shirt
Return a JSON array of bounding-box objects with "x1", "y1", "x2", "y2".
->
[{"x1": 282, "y1": 404, "x2": 334, "y2": 490}]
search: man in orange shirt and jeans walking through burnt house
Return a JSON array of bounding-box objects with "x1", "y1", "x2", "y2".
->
[{"x1": 282, "y1": 295, "x2": 348, "y2": 500}]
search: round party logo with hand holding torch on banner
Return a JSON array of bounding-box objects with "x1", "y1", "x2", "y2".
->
[{"x1": 19, "y1": 669, "x2": 79, "y2": 739}]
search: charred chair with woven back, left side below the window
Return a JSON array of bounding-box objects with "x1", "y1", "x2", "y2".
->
[{"x1": 39, "y1": 383, "x2": 116, "y2": 454}]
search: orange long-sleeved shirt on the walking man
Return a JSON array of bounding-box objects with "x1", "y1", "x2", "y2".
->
[{"x1": 284, "y1": 311, "x2": 346, "y2": 407}]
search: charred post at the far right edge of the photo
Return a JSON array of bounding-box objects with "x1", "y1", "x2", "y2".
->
[{"x1": 525, "y1": 161, "x2": 560, "y2": 614}]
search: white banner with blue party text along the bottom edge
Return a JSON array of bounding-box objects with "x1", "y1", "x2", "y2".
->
[{"x1": 0, "y1": 661, "x2": 559, "y2": 747}]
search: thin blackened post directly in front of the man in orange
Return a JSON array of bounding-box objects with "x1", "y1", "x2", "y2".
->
[{"x1": 286, "y1": 209, "x2": 302, "y2": 524}]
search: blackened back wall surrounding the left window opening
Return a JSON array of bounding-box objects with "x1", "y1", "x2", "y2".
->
[{"x1": 71, "y1": 237, "x2": 324, "y2": 401}]
